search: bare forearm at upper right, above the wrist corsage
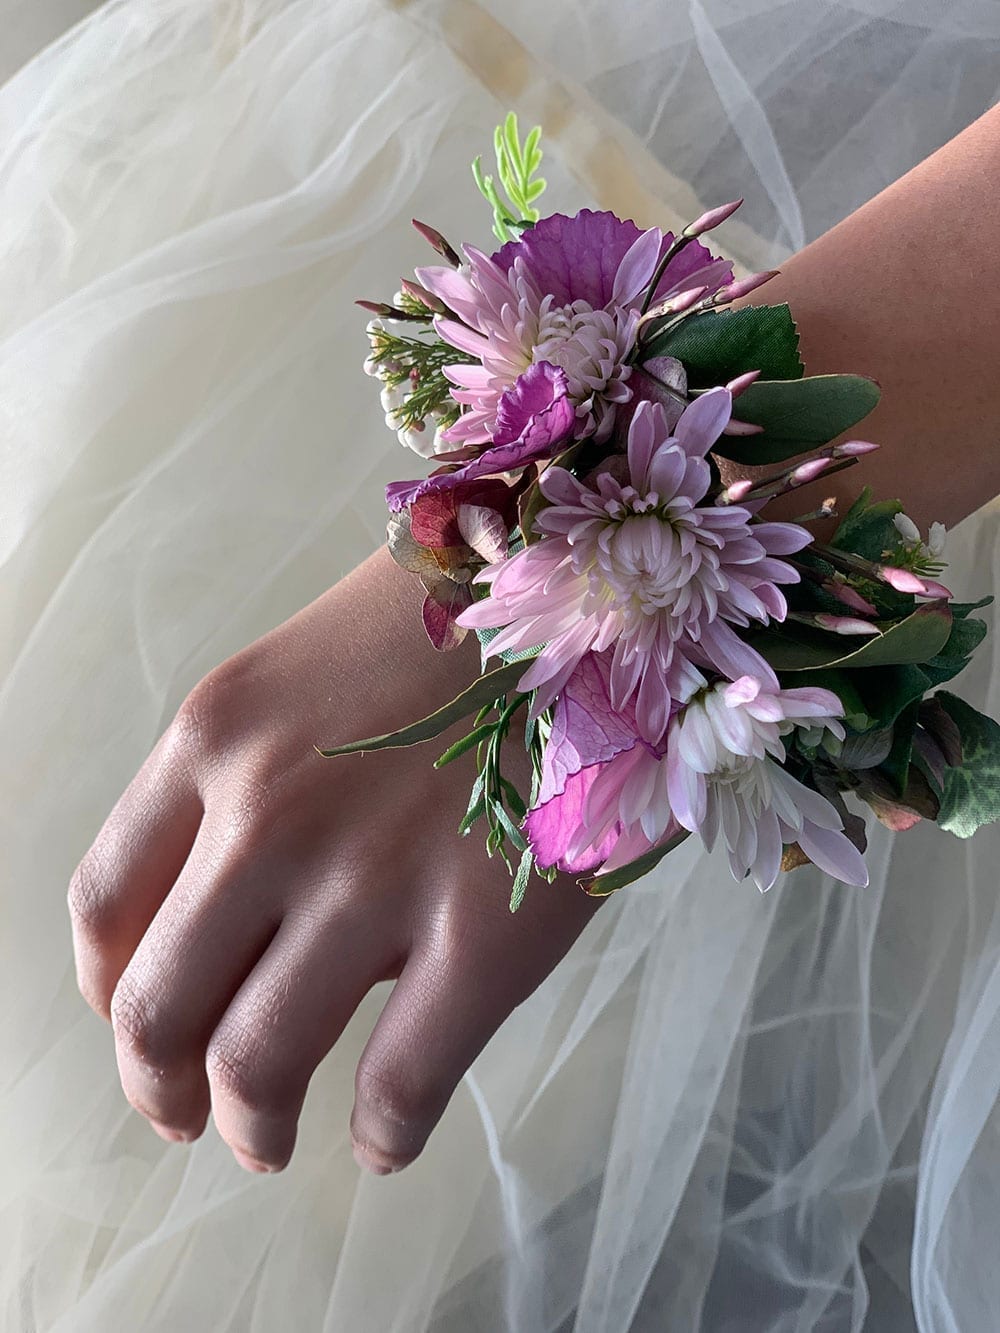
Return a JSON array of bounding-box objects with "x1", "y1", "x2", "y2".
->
[{"x1": 733, "y1": 107, "x2": 1000, "y2": 528}]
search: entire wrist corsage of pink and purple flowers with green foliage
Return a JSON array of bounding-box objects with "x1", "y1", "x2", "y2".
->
[{"x1": 317, "y1": 115, "x2": 1000, "y2": 910}]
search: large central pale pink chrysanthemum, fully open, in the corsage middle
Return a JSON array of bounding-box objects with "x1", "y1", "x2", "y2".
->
[{"x1": 459, "y1": 388, "x2": 812, "y2": 744}]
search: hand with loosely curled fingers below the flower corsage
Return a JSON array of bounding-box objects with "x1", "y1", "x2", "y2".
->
[{"x1": 68, "y1": 549, "x2": 610, "y2": 1174}]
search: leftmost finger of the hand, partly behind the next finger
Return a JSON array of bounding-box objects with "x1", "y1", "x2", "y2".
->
[{"x1": 67, "y1": 728, "x2": 204, "y2": 1018}]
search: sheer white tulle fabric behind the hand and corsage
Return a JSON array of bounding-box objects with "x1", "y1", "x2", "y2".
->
[{"x1": 0, "y1": 0, "x2": 1000, "y2": 1333}]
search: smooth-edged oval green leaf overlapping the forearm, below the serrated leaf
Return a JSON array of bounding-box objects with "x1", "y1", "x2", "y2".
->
[{"x1": 712, "y1": 375, "x2": 879, "y2": 467}]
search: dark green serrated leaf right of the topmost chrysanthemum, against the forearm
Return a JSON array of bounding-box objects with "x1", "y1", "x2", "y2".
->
[{"x1": 643, "y1": 305, "x2": 804, "y2": 391}]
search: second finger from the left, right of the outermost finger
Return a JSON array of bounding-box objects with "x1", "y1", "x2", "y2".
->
[{"x1": 111, "y1": 816, "x2": 287, "y2": 1140}]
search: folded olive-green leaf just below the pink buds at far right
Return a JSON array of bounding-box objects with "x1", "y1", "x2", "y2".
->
[{"x1": 749, "y1": 604, "x2": 952, "y2": 670}]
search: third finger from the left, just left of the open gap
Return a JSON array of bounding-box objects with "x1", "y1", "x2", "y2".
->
[{"x1": 207, "y1": 906, "x2": 403, "y2": 1170}]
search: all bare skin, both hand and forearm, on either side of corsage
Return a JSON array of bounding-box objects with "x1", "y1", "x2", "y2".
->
[{"x1": 68, "y1": 108, "x2": 1000, "y2": 1173}]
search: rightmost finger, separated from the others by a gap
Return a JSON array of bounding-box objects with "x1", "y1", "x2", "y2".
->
[{"x1": 351, "y1": 886, "x2": 599, "y2": 1174}]
